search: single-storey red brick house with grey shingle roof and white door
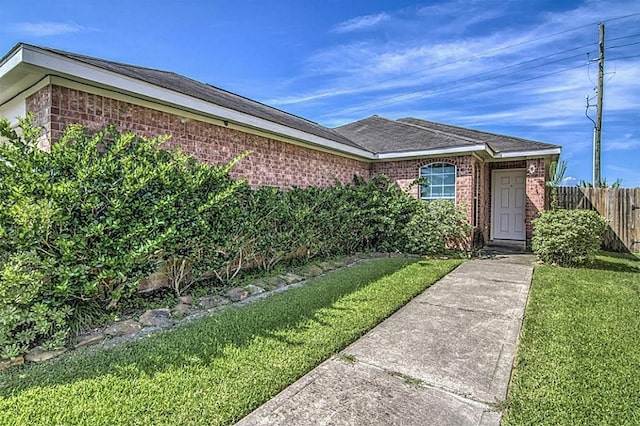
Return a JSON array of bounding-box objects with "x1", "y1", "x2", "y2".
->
[{"x1": 0, "y1": 44, "x2": 560, "y2": 244}]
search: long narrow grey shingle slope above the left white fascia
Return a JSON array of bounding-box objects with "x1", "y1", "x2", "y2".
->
[{"x1": 32, "y1": 46, "x2": 360, "y2": 148}]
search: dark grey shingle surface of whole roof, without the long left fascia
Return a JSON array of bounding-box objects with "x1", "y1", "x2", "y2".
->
[{"x1": 12, "y1": 43, "x2": 560, "y2": 158}]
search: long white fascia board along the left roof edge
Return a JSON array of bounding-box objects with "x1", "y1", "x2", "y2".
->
[{"x1": 21, "y1": 46, "x2": 375, "y2": 160}]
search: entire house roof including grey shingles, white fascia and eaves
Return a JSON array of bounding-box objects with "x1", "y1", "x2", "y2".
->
[{"x1": 0, "y1": 43, "x2": 560, "y2": 160}]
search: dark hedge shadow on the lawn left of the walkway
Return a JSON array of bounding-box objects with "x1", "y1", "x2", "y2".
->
[{"x1": 0, "y1": 259, "x2": 430, "y2": 397}]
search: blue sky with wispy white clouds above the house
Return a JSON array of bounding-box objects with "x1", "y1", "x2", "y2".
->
[{"x1": 0, "y1": 0, "x2": 640, "y2": 186}]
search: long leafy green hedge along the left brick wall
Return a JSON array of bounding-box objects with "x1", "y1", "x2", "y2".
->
[{"x1": 0, "y1": 117, "x2": 444, "y2": 359}]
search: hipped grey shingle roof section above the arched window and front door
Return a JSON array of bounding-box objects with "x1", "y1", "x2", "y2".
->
[{"x1": 335, "y1": 115, "x2": 560, "y2": 154}]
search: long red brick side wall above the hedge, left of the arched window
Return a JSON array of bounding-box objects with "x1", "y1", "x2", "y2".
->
[{"x1": 27, "y1": 85, "x2": 369, "y2": 188}]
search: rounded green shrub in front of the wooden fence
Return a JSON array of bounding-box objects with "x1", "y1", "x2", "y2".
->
[{"x1": 531, "y1": 209, "x2": 607, "y2": 266}]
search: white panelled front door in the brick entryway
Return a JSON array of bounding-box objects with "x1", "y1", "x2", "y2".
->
[{"x1": 491, "y1": 170, "x2": 527, "y2": 241}]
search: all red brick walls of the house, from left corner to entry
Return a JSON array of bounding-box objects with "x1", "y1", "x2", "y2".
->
[{"x1": 27, "y1": 85, "x2": 545, "y2": 241}]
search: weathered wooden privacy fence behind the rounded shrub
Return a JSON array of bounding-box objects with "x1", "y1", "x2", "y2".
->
[{"x1": 557, "y1": 187, "x2": 640, "y2": 253}]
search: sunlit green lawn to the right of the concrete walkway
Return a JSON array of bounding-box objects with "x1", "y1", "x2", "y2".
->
[{"x1": 503, "y1": 253, "x2": 640, "y2": 425}]
